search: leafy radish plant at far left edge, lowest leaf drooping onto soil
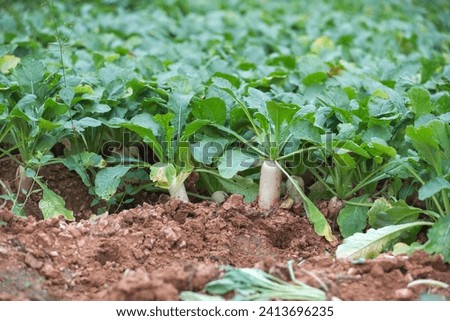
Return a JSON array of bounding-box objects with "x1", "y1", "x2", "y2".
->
[{"x1": 2, "y1": 57, "x2": 73, "y2": 220}]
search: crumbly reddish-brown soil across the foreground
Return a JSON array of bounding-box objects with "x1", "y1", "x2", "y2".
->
[{"x1": 0, "y1": 164, "x2": 450, "y2": 300}]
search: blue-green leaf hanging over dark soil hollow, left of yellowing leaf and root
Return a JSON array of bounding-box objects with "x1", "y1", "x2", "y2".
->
[{"x1": 94, "y1": 165, "x2": 131, "y2": 200}]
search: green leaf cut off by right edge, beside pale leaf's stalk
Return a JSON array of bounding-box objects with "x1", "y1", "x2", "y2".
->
[{"x1": 424, "y1": 215, "x2": 450, "y2": 263}]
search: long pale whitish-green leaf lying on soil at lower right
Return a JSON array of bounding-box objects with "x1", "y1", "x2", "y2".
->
[{"x1": 336, "y1": 222, "x2": 433, "y2": 259}]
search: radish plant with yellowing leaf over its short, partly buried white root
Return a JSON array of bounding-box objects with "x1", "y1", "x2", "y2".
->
[{"x1": 109, "y1": 77, "x2": 209, "y2": 202}]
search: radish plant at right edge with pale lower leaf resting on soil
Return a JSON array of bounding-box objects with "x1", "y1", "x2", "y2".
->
[{"x1": 336, "y1": 101, "x2": 450, "y2": 262}]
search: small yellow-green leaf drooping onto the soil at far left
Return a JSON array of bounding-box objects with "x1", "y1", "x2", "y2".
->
[{"x1": 38, "y1": 183, "x2": 75, "y2": 221}]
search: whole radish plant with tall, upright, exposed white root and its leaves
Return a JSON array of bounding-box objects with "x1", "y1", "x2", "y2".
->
[{"x1": 201, "y1": 79, "x2": 333, "y2": 241}]
